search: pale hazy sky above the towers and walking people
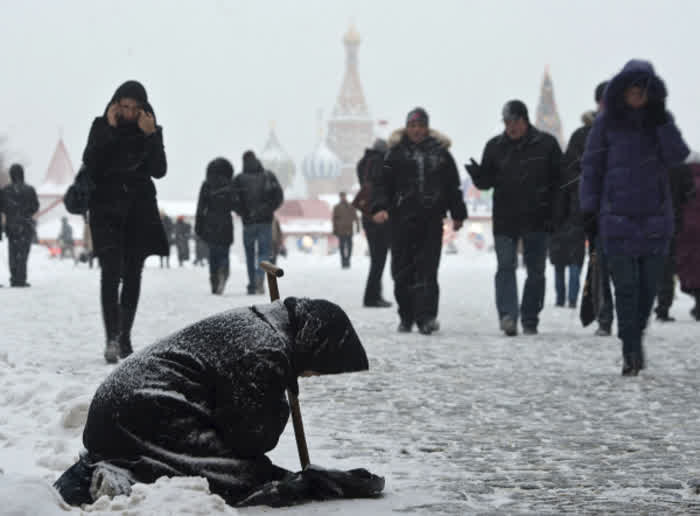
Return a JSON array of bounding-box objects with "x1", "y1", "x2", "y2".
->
[{"x1": 0, "y1": 0, "x2": 700, "y2": 199}]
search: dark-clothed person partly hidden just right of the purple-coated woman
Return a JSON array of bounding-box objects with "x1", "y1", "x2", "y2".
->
[{"x1": 654, "y1": 165, "x2": 696, "y2": 322}]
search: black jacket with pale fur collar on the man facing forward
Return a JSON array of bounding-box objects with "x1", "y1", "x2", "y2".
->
[{"x1": 371, "y1": 130, "x2": 467, "y2": 224}]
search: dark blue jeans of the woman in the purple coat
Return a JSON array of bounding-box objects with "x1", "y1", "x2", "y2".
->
[{"x1": 608, "y1": 256, "x2": 665, "y2": 354}]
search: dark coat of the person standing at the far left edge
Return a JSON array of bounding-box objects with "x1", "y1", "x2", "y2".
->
[{"x1": 0, "y1": 165, "x2": 39, "y2": 242}]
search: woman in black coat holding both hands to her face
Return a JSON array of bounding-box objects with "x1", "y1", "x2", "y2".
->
[{"x1": 83, "y1": 81, "x2": 168, "y2": 363}]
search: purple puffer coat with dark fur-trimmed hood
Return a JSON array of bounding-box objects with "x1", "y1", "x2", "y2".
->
[{"x1": 581, "y1": 60, "x2": 690, "y2": 256}]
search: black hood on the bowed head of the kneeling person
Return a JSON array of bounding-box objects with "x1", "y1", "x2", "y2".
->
[{"x1": 284, "y1": 297, "x2": 369, "y2": 374}]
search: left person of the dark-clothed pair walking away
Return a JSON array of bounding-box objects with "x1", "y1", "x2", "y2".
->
[{"x1": 194, "y1": 158, "x2": 237, "y2": 295}]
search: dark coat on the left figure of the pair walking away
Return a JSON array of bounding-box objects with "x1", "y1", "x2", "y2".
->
[{"x1": 194, "y1": 159, "x2": 237, "y2": 246}]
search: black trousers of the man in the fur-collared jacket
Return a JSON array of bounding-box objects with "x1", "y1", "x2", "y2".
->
[{"x1": 391, "y1": 219, "x2": 442, "y2": 324}]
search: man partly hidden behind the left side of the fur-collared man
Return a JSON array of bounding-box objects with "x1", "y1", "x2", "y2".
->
[{"x1": 352, "y1": 138, "x2": 391, "y2": 308}]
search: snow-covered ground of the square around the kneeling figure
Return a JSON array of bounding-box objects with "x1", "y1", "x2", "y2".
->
[{"x1": 0, "y1": 241, "x2": 700, "y2": 516}]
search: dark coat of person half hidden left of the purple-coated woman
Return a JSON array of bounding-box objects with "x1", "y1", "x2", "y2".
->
[{"x1": 549, "y1": 112, "x2": 595, "y2": 267}]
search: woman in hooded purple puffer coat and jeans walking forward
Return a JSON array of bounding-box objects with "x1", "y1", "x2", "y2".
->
[{"x1": 581, "y1": 60, "x2": 697, "y2": 376}]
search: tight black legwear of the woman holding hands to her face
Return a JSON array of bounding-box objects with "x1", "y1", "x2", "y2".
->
[{"x1": 100, "y1": 251, "x2": 144, "y2": 340}]
